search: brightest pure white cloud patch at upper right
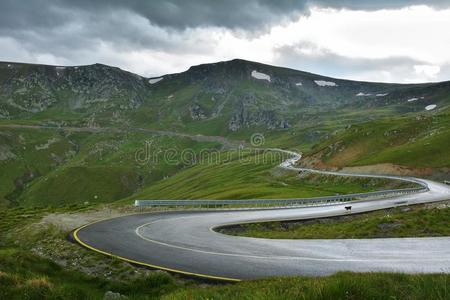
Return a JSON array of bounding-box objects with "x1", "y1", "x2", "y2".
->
[{"x1": 268, "y1": 6, "x2": 450, "y2": 62}]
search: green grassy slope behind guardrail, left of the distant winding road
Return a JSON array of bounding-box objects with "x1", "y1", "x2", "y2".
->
[{"x1": 0, "y1": 128, "x2": 412, "y2": 206}]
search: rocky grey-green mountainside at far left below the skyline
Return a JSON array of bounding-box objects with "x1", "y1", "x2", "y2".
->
[{"x1": 0, "y1": 64, "x2": 148, "y2": 117}]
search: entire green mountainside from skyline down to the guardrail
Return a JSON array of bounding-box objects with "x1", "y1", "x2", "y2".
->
[{"x1": 0, "y1": 60, "x2": 450, "y2": 206}]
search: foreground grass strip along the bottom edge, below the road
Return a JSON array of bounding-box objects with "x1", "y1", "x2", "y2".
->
[{"x1": 0, "y1": 249, "x2": 450, "y2": 300}]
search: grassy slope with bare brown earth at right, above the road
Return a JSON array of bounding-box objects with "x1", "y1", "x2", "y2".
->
[{"x1": 307, "y1": 110, "x2": 450, "y2": 168}]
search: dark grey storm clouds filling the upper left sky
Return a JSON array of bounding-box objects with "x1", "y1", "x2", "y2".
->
[{"x1": 0, "y1": 0, "x2": 449, "y2": 54}]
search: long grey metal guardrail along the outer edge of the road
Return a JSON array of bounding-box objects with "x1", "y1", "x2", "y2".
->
[{"x1": 134, "y1": 187, "x2": 428, "y2": 208}]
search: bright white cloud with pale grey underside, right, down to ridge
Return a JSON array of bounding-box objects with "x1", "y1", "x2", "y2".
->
[{"x1": 261, "y1": 6, "x2": 450, "y2": 82}]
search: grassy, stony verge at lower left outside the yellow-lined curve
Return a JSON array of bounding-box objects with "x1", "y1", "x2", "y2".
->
[{"x1": 0, "y1": 204, "x2": 190, "y2": 299}]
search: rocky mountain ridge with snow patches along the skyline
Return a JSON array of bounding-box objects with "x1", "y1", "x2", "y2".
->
[{"x1": 0, "y1": 59, "x2": 450, "y2": 135}]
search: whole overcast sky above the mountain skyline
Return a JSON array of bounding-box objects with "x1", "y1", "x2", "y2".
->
[{"x1": 0, "y1": 0, "x2": 450, "y2": 82}]
